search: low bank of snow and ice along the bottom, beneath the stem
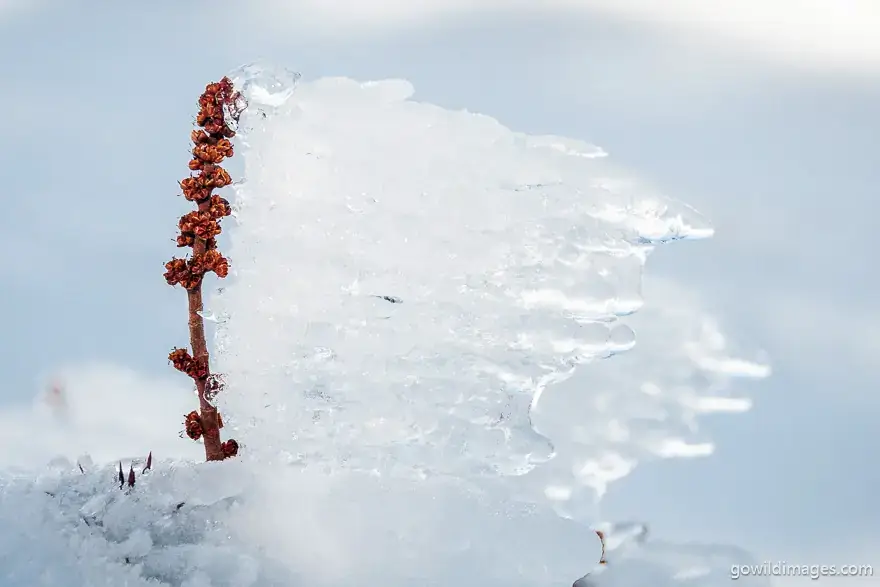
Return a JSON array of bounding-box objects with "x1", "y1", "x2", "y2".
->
[{"x1": 0, "y1": 461, "x2": 766, "y2": 587}]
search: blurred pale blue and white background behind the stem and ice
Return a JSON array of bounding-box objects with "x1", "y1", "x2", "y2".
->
[{"x1": 0, "y1": 0, "x2": 880, "y2": 582}]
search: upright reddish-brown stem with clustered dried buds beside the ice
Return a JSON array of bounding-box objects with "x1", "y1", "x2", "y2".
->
[{"x1": 165, "y1": 77, "x2": 246, "y2": 461}]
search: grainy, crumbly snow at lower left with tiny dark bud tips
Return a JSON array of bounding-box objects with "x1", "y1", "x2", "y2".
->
[{"x1": 0, "y1": 460, "x2": 259, "y2": 587}]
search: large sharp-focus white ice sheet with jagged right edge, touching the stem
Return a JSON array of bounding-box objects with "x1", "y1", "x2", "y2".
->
[{"x1": 211, "y1": 78, "x2": 740, "y2": 486}]
